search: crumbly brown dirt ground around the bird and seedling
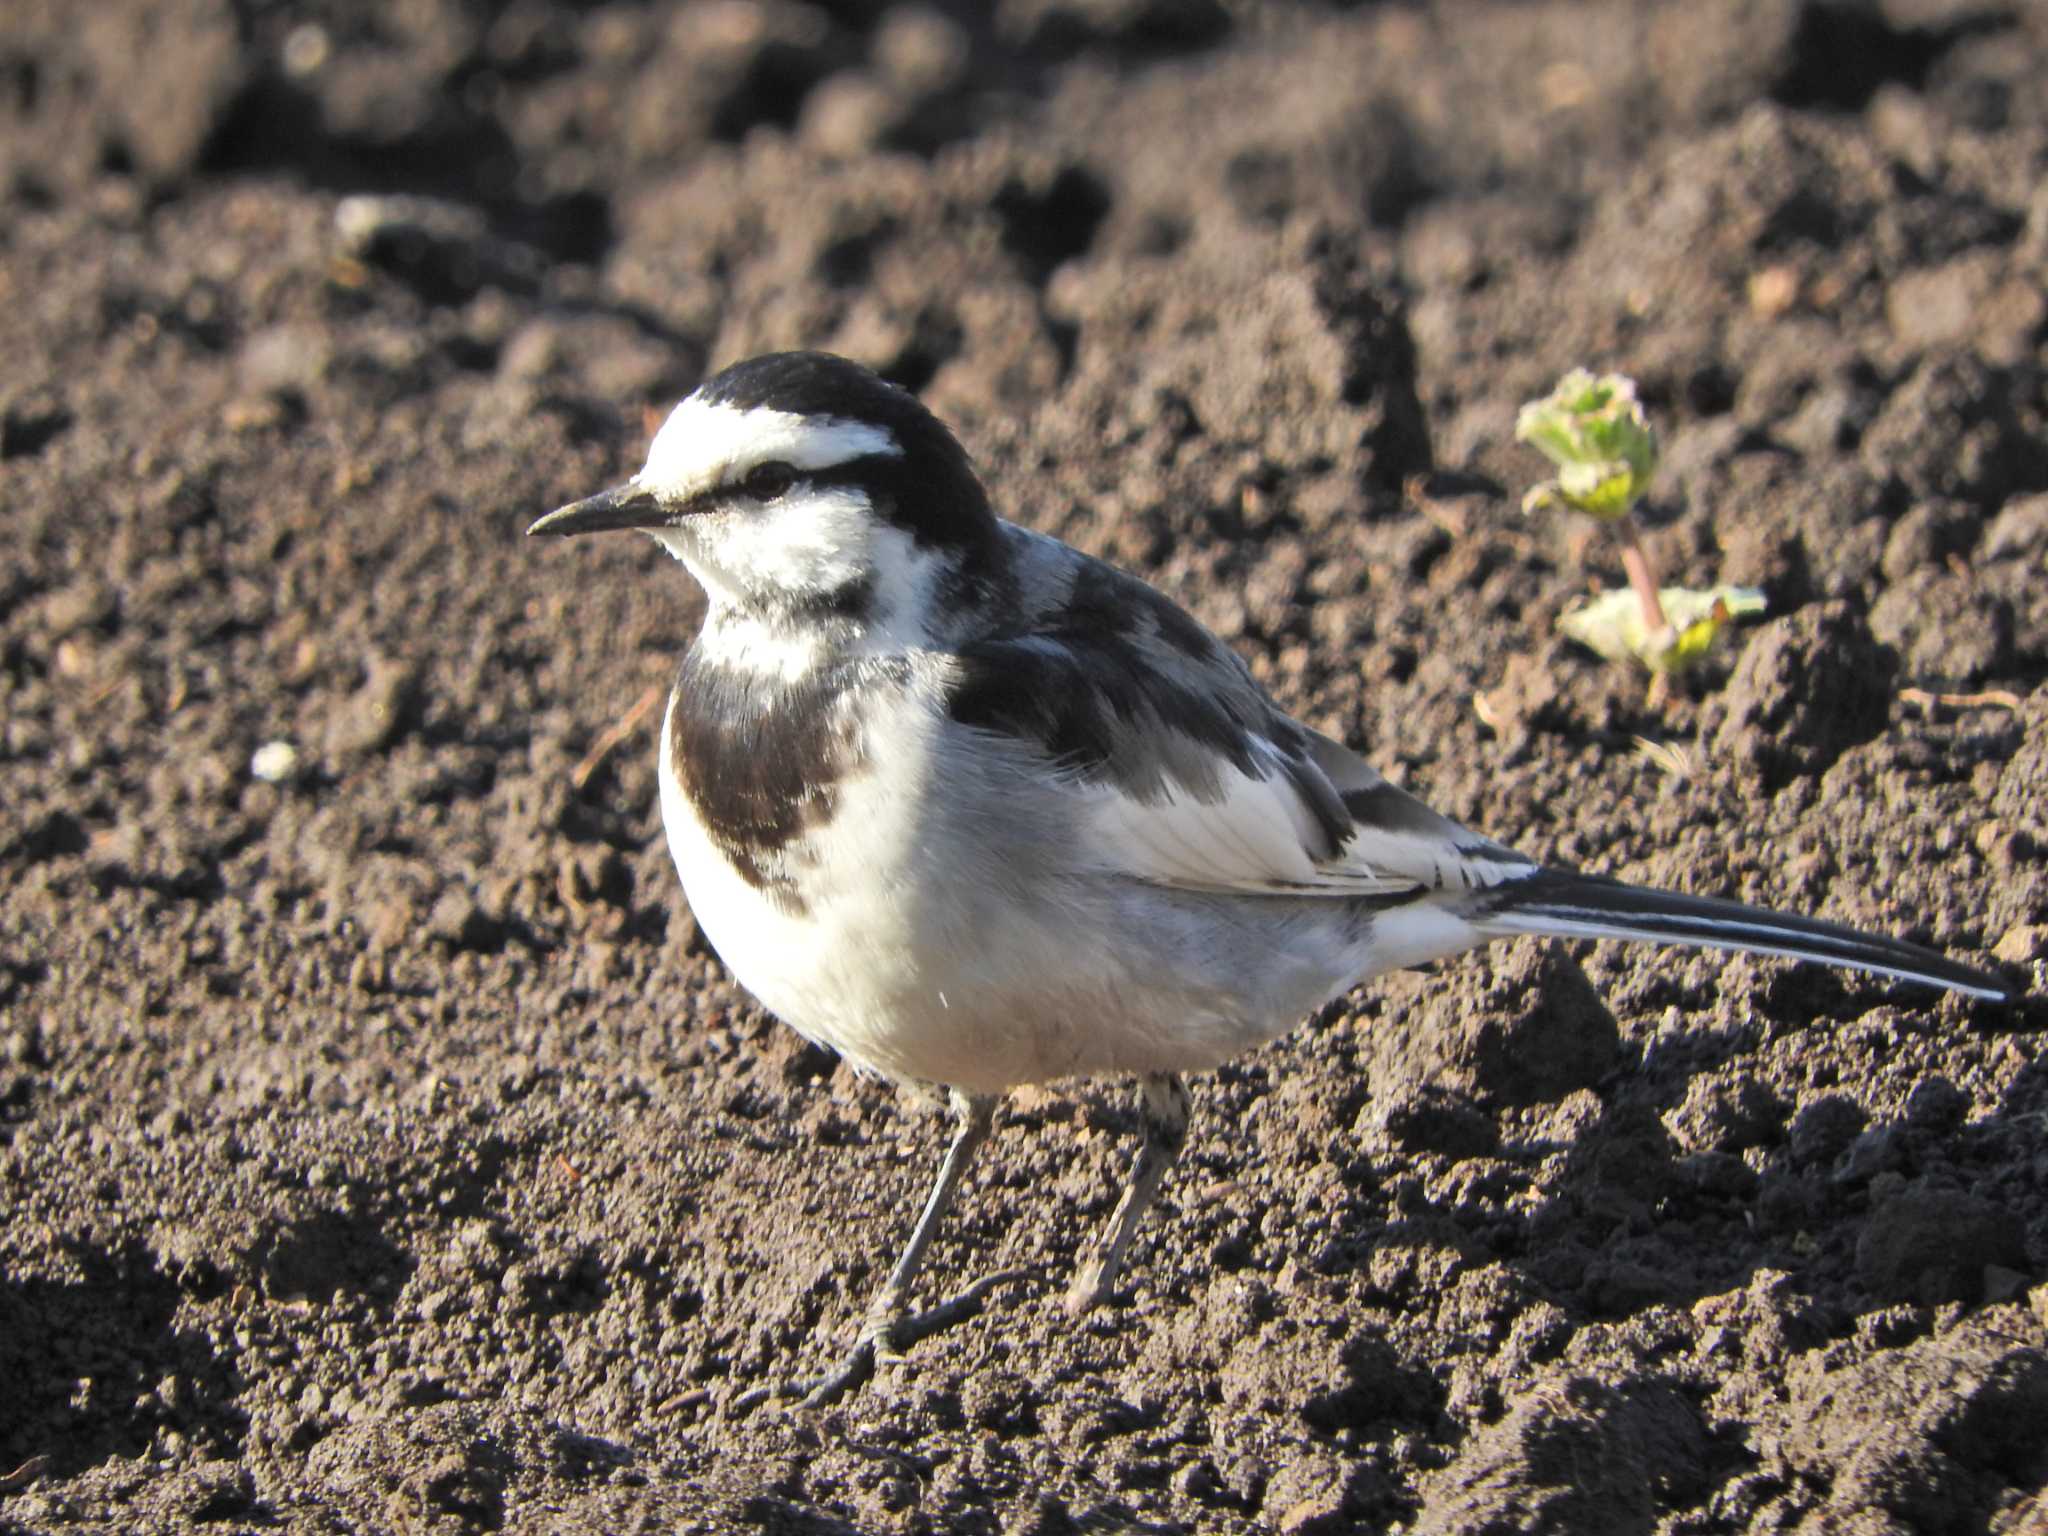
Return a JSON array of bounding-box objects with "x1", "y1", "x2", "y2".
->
[{"x1": 0, "y1": 0, "x2": 2048, "y2": 1536}]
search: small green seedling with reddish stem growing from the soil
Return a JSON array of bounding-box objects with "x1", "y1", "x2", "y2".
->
[{"x1": 1516, "y1": 369, "x2": 1763, "y2": 702}]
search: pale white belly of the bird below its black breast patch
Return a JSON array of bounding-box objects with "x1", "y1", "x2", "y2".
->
[{"x1": 662, "y1": 694, "x2": 1392, "y2": 1092}]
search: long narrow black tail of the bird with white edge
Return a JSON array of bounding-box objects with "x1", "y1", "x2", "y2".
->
[{"x1": 1470, "y1": 868, "x2": 2019, "y2": 1004}]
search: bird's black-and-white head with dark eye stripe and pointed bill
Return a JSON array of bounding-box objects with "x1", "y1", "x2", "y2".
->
[{"x1": 526, "y1": 352, "x2": 997, "y2": 630}]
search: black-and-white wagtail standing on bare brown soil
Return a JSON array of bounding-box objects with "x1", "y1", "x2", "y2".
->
[{"x1": 528, "y1": 352, "x2": 2017, "y2": 1405}]
